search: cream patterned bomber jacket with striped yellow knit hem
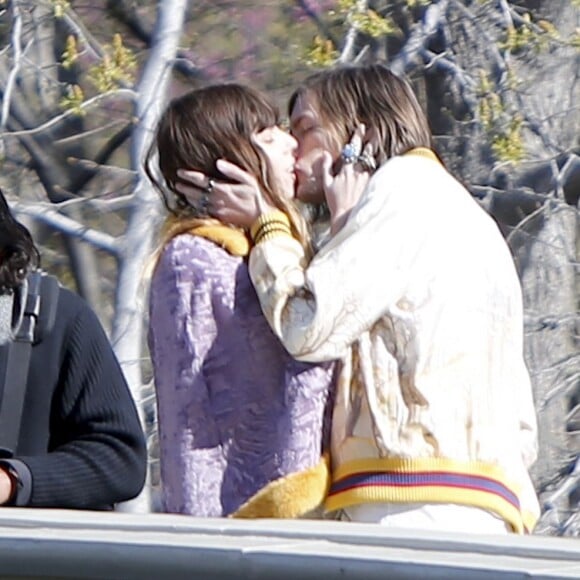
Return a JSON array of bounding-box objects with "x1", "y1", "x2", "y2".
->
[{"x1": 250, "y1": 149, "x2": 539, "y2": 532}]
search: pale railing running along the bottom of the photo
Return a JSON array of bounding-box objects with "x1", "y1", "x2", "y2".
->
[{"x1": 0, "y1": 508, "x2": 580, "y2": 580}]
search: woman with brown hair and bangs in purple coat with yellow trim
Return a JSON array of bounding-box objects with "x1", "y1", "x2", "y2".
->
[{"x1": 146, "y1": 84, "x2": 332, "y2": 517}]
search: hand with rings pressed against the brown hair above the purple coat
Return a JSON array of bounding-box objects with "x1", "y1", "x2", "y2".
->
[{"x1": 176, "y1": 159, "x2": 274, "y2": 228}]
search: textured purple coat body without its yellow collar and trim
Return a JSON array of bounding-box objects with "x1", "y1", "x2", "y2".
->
[{"x1": 149, "y1": 234, "x2": 333, "y2": 516}]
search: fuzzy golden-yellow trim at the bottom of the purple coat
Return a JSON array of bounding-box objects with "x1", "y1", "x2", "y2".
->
[{"x1": 229, "y1": 455, "x2": 330, "y2": 519}]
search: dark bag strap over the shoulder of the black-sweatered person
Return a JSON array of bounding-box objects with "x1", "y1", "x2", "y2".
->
[{"x1": 0, "y1": 271, "x2": 56, "y2": 457}]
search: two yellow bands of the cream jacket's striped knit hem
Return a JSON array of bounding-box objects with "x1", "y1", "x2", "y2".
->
[{"x1": 325, "y1": 458, "x2": 538, "y2": 534}]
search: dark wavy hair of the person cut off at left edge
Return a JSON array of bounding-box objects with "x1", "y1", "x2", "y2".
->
[{"x1": 0, "y1": 190, "x2": 40, "y2": 294}]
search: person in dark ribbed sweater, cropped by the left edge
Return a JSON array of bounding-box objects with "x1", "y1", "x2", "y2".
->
[{"x1": 0, "y1": 191, "x2": 147, "y2": 509}]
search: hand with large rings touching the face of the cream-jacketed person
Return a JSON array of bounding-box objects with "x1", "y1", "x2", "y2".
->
[{"x1": 322, "y1": 125, "x2": 373, "y2": 235}]
